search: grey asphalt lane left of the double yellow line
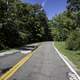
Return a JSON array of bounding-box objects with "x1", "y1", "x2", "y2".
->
[{"x1": 0, "y1": 52, "x2": 25, "y2": 76}]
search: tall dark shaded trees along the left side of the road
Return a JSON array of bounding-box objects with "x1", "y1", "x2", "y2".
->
[{"x1": 0, "y1": 0, "x2": 51, "y2": 49}]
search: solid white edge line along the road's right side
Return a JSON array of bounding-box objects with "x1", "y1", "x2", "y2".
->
[{"x1": 53, "y1": 42, "x2": 80, "y2": 80}]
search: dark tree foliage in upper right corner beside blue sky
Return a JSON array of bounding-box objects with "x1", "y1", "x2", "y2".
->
[{"x1": 67, "y1": 0, "x2": 80, "y2": 28}]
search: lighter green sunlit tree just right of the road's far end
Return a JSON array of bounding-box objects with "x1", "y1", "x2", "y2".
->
[{"x1": 49, "y1": 12, "x2": 69, "y2": 41}]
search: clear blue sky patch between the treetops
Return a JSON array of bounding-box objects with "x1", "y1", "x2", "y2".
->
[{"x1": 23, "y1": 0, "x2": 67, "y2": 19}]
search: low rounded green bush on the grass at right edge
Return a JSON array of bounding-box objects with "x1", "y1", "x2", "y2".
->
[{"x1": 66, "y1": 31, "x2": 80, "y2": 50}]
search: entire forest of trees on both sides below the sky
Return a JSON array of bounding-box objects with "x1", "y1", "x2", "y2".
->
[{"x1": 0, "y1": 0, "x2": 80, "y2": 50}]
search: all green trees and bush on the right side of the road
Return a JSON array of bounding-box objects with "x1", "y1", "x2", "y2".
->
[{"x1": 49, "y1": 0, "x2": 80, "y2": 50}]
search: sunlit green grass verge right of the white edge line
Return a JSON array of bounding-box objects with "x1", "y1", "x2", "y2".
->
[{"x1": 54, "y1": 42, "x2": 80, "y2": 69}]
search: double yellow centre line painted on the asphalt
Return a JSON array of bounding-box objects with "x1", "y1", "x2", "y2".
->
[{"x1": 0, "y1": 53, "x2": 32, "y2": 80}]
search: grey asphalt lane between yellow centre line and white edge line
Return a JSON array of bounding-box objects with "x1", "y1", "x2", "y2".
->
[{"x1": 9, "y1": 42, "x2": 70, "y2": 80}]
